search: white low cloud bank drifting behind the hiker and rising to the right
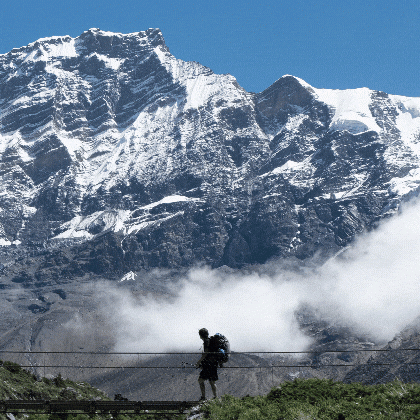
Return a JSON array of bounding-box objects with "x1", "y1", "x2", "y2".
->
[{"x1": 93, "y1": 199, "x2": 420, "y2": 352}]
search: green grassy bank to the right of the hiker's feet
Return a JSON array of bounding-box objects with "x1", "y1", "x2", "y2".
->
[{"x1": 202, "y1": 379, "x2": 420, "y2": 420}]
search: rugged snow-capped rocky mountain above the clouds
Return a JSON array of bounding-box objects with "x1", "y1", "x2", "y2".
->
[{"x1": 0, "y1": 29, "x2": 420, "y2": 281}]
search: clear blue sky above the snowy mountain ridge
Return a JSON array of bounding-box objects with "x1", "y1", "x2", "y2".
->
[{"x1": 0, "y1": 0, "x2": 420, "y2": 96}]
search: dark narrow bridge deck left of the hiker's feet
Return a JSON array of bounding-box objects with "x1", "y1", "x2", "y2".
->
[{"x1": 0, "y1": 400, "x2": 199, "y2": 414}]
